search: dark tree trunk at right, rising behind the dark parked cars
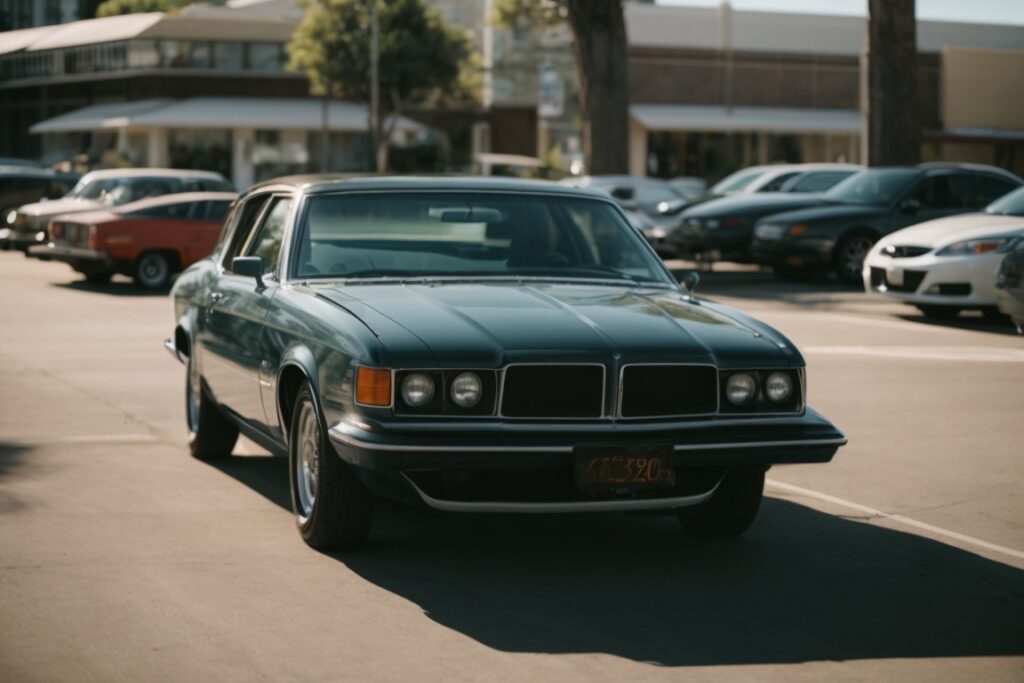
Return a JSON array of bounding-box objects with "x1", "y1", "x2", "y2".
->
[{"x1": 860, "y1": 0, "x2": 921, "y2": 166}]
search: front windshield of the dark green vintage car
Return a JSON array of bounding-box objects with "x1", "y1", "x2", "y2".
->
[{"x1": 294, "y1": 193, "x2": 675, "y2": 287}]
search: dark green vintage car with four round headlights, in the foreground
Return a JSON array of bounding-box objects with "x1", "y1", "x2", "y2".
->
[{"x1": 166, "y1": 176, "x2": 846, "y2": 548}]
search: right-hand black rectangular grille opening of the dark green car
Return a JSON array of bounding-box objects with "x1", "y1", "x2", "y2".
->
[{"x1": 621, "y1": 366, "x2": 718, "y2": 418}]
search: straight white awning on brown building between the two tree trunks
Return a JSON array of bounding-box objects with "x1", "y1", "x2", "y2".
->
[{"x1": 630, "y1": 104, "x2": 860, "y2": 134}]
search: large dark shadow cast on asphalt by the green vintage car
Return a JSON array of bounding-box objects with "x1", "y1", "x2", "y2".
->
[{"x1": 207, "y1": 458, "x2": 1024, "y2": 667}]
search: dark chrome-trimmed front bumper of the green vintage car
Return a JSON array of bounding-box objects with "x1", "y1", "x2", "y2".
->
[{"x1": 329, "y1": 409, "x2": 847, "y2": 512}]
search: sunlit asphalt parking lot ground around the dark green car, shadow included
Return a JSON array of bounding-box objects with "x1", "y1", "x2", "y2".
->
[{"x1": 0, "y1": 252, "x2": 1024, "y2": 681}]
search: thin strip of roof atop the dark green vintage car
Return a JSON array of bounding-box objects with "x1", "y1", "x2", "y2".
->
[{"x1": 245, "y1": 174, "x2": 609, "y2": 201}]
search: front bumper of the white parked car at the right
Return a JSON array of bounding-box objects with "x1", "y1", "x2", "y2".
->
[{"x1": 861, "y1": 252, "x2": 1005, "y2": 308}]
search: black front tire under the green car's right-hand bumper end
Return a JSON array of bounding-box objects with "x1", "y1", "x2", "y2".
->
[{"x1": 676, "y1": 469, "x2": 765, "y2": 539}]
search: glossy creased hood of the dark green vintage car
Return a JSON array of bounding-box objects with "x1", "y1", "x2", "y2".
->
[{"x1": 312, "y1": 283, "x2": 802, "y2": 368}]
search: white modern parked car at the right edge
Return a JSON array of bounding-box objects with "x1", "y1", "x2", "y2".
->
[{"x1": 862, "y1": 187, "x2": 1024, "y2": 318}]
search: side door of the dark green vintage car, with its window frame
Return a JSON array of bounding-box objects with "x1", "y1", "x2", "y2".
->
[{"x1": 201, "y1": 195, "x2": 292, "y2": 428}]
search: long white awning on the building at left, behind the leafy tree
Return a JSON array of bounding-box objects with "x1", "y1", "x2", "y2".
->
[{"x1": 29, "y1": 97, "x2": 427, "y2": 133}]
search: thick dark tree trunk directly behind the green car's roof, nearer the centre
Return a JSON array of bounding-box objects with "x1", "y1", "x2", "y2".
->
[{"x1": 568, "y1": 0, "x2": 630, "y2": 174}]
